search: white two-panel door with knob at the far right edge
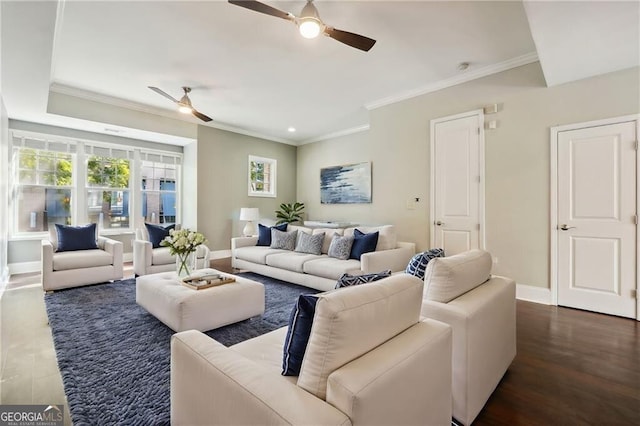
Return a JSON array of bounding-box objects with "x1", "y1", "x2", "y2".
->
[{"x1": 557, "y1": 122, "x2": 637, "y2": 318}]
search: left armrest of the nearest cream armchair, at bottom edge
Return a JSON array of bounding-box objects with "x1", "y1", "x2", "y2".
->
[{"x1": 171, "y1": 330, "x2": 351, "y2": 425}]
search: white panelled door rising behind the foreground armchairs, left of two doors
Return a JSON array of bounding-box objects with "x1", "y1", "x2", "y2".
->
[{"x1": 431, "y1": 112, "x2": 483, "y2": 256}]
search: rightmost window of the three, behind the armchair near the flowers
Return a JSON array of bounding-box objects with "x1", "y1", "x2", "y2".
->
[{"x1": 141, "y1": 161, "x2": 178, "y2": 224}]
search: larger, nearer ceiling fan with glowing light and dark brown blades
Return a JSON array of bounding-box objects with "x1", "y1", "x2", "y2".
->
[{"x1": 229, "y1": 0, "x2": 376, "y2": 52}]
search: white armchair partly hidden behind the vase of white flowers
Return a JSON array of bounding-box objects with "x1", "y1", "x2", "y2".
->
[{"x1": 133, "y1": 225, "x2": 211, "y2": 276}]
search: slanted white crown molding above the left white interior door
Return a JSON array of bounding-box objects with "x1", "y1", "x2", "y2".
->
[{"x1": 365, "y1": 52, "x2": 538, "y2": 110}]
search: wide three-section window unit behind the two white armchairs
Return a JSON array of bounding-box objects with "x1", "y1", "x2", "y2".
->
[{"x1": 9, "y1": 130, "x2": 182, "y2": 239}]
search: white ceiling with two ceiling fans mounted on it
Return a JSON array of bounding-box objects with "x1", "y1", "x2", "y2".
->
[{"x1": 0, "y1": 0, "x2": 640, "y2": 144}]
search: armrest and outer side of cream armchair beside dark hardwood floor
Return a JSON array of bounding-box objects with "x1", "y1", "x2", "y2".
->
[{"x1": 421, "y1": 276, "x2": 516, "y2": 424}]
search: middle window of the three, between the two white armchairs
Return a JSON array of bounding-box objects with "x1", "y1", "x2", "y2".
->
[{"x1": 87, "y1": 155, "x2": 130, "y2": 229}]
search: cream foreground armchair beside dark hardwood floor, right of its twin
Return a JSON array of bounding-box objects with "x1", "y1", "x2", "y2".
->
[{"x1": 421, "y1": 250, "x2": 516, "y2": 425}]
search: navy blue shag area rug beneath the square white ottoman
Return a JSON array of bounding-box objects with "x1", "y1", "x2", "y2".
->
[{"x1": 45, "y1": 273, "x2": 317, "y2": 426}]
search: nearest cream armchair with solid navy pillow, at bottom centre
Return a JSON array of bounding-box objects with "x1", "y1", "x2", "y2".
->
[{"x1": 171, "y1": 274, "x2": 451, "y2": 426}]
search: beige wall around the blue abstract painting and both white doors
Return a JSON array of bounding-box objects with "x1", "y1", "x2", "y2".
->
[{"x1": 297, "y1": 63, "x2": 640, "y2": 288}]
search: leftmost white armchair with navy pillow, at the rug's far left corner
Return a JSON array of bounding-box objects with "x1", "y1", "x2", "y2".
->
[{"x1": 41, "y1": 237, "x2": 123, "y2": 291}]
